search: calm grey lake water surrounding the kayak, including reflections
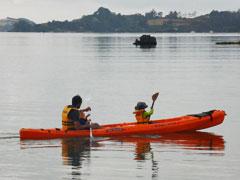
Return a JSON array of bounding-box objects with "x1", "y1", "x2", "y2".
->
[{"x1": 0, "y1": 33, "x2": 240, "y2": 180}]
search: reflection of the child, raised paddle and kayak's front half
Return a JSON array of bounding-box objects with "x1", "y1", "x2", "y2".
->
[{"x1": 113, "y1": 132, "x2": 225, "y2": 179}]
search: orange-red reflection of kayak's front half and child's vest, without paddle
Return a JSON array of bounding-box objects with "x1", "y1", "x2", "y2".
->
[{"x1": 112, "y1": 132, "x2": 225, "y2": 160}]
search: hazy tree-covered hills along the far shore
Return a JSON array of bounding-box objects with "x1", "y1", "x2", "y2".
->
[{"x1": 0, "y1": 7, "x2": 240, "y2": 33}]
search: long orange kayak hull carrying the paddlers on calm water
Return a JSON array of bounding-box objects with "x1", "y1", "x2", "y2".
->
[{"x1": 19, "y1": 110, "x2": 226, "y2": 140}]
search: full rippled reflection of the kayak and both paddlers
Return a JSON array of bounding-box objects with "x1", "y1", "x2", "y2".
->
[{"x1": 21, "y1": 132, "x2": 225, "y2": 179}]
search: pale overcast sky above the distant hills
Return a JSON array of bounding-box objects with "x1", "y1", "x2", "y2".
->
[{"x1": 0, "y1": 0, "x2": 240, "y2": 23}]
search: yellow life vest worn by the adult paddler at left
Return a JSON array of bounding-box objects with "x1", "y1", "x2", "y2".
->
[{"x1": 62, "y1": 106, "x2": 79, "y2": 131}]
